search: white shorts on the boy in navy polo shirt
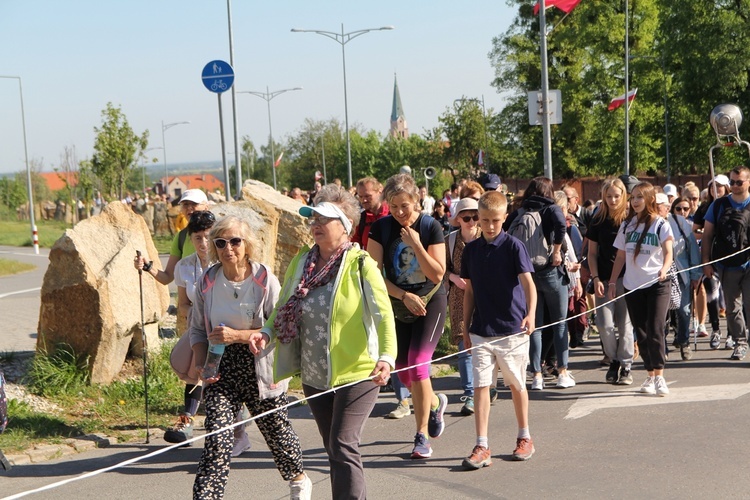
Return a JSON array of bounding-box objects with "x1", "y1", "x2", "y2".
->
[{"x1": 471, "y1": 334, "x2": 530, "y2": 391}]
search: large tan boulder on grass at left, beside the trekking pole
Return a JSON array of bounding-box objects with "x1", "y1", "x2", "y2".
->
[{"x1": 37, "y1": 203, "x2": 169, "y2": 383}]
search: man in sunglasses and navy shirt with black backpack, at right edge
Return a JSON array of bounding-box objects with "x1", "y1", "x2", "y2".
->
[{"x1": 701, "y1": 166, "x2": 750, "y2": 360}]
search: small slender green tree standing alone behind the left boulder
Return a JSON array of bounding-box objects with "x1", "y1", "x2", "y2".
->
[{"x1": 91, "y1": 102, "x2": 148, "y2": 198}]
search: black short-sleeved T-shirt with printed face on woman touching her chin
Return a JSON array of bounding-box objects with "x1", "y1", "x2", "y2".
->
[{"x1": 370, "y1": 214, "x2": 445, "y2": 295}]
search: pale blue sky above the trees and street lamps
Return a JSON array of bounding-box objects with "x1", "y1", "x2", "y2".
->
[{"x1": 0, "y1": 0, "x2": 515, "y2": 176}]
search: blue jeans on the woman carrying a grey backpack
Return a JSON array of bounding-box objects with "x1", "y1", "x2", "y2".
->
[{"x1": 529, "y1": 267, "x2": 568, "y2": 373}]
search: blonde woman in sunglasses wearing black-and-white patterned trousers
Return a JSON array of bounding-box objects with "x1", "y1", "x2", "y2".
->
[{"x1": 189, "y1": 216, "x2": 312, "y2": 499}]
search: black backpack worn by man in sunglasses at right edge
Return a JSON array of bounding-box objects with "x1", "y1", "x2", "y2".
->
[{"x1": 711, "y1": 196, "x2": 750, "y2": 267}]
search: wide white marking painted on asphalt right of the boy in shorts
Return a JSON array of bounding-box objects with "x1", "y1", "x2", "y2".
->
[{"x1": 565, "y1": 384, "x2": 750, "y2": 420}]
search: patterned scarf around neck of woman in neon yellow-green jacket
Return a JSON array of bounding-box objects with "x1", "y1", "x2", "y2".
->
[{"x1": 273, "y1": 241, "x2": 352, "y2": 344}]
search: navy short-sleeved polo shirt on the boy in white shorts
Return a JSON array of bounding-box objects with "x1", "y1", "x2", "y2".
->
[{"x1": 461, "y1": 231, "x2": 534, "y2": 337}]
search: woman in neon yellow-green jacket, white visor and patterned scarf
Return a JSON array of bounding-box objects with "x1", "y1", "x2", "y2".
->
[{"x1": 251, "y1": 184, "x2": 396, "y2": 498}]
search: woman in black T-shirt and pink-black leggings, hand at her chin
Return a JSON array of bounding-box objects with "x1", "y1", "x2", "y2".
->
[{"x1": 367, "y1": 174, "x2": 450, "y2": 459}]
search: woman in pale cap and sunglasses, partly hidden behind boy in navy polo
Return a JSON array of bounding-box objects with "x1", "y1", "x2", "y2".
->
[{"x1": 445, "y1": 198, "x2": 482, "y2": 415}]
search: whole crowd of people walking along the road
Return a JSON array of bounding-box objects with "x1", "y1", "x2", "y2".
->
[{"x1": 134, "y1": 167, "x2": 750, "y2": 499}]
